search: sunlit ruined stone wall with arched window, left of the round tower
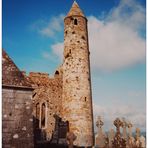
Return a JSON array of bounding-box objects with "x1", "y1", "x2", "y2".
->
[{"x1": 29, "y1": 70, "x2": 62, "y2": 140}]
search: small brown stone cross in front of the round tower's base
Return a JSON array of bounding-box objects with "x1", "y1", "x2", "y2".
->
[{"x1": 66, "y1": 132, "x2": 77, "y2": 148}]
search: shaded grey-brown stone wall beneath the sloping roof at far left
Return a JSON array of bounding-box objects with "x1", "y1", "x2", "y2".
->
[{"x1": 2, "y1": 88, "x2": 34, "y2": 148}]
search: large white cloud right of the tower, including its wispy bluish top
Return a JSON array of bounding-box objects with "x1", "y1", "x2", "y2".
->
[{"x1": 88, "y1": 0, "x2": 146, "y2": 71}]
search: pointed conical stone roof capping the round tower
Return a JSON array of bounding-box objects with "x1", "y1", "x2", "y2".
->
[{"x1": 67, "y1": 1, "x2": 85, "y2": 17}]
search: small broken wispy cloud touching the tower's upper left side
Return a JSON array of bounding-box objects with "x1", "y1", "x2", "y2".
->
[{"x1": 31, "y1": 14, "x2": 64, "y2": 62}]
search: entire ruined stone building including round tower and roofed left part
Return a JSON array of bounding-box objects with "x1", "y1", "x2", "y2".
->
[{"x1": 2, "y1": 2, "x2": 94, "y2": 148}]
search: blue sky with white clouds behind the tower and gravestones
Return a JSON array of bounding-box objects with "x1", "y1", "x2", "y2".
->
[{"x1": 2, "y1": 0, "x2": 146, "y2": 131}]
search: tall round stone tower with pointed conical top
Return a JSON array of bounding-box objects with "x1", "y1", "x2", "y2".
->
[{"x1": 62, "y1": 1, "x2": 94, "y2": 147}]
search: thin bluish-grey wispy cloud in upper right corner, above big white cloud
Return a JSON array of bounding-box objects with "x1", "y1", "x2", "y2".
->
[{"x1": 108, "y1": 0, "x2": 145, "y2": 30}]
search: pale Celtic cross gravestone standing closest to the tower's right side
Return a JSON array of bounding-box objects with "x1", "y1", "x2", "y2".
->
[{"x1": 95, "y1": 116, "x2": 107, "y2": 148}]
